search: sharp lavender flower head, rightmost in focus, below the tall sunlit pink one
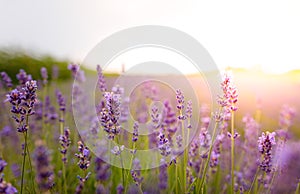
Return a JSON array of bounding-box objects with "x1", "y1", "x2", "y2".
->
[{"x1": 258, "y1": 131, "x2": 276, "y2": 173}]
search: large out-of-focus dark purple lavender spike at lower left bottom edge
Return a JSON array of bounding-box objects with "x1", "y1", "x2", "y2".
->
[{"x1": 34, "y1": 141, "x2": 54, "y2": 191}]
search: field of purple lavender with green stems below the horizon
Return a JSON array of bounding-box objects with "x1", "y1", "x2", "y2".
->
[{"x1": 0, "y1": 64, "x2": 300, "y2": 194}]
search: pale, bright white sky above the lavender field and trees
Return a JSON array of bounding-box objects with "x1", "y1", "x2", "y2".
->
[{"x1": 0, "y1": 0, "x2": 300, "y2": 73}]
